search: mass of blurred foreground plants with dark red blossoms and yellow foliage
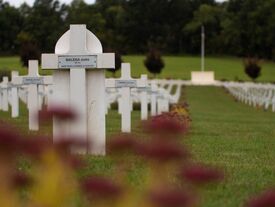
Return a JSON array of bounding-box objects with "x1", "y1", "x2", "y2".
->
[{"x1": 0, "y1": 104, "x2": 224, "y2": 207}]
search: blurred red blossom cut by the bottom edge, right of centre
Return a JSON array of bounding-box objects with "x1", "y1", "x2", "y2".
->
[{"x1": 149, "y1": 190, "x2": 192, "y2": 207}]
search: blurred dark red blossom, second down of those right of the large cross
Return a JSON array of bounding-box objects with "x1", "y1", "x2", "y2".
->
[{"x1": 138, "y1": 140, "x2": 188, "y2": 162}]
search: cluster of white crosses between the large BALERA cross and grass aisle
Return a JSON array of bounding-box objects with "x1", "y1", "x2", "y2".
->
[{"x1": 105, "y1": 63, "x2": 182, "y2": 132}]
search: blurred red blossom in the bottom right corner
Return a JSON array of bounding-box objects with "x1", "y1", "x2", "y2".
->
[{"x1": 247, "y1": 189, "x2": 275, "y2": 207}]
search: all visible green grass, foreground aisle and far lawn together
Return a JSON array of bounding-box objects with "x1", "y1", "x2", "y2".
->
[{"x1": 0, "y1": 56, "x2": 275, "y2": 207}]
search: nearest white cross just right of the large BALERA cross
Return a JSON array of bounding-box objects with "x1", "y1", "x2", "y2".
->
[{"x1": 106, "y1": 63, "x2": 147, "y2": 133}]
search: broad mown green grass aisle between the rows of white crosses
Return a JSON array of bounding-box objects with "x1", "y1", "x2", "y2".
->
[{"x1": 185, "y1": 87, "x2": 275, "y2": 207}]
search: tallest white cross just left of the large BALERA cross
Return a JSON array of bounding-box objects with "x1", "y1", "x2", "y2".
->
[{"x1": 13, "y1": 60, "x2": 52, "y2": 130}]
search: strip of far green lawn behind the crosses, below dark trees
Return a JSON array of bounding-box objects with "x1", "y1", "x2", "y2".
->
[{"x1": 0, "y1": 56, "x2": 275, "y2": 82}]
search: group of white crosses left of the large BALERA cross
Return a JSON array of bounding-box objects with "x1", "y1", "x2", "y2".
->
[{"x1": 0, "y1": 60, "x2": 52, "y2": 130}]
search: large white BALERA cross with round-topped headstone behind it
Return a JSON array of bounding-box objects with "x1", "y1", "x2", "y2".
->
[{"x1": 42, "y1": 25, "x2": 115, "y2": 155}]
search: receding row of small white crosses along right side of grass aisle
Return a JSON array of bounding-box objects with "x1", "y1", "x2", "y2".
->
[{"x1": 222, "y1": 82, "x2": 275, "y2": 112}]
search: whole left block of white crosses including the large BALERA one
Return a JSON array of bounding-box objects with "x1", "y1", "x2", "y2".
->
[{"x1": 0, "y1": 25, "x2": 185, "y2": 155}]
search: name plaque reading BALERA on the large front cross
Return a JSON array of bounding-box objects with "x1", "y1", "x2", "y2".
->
[{"x1": 58, "y1": 55, "x2": 97, "y2": 69}]
